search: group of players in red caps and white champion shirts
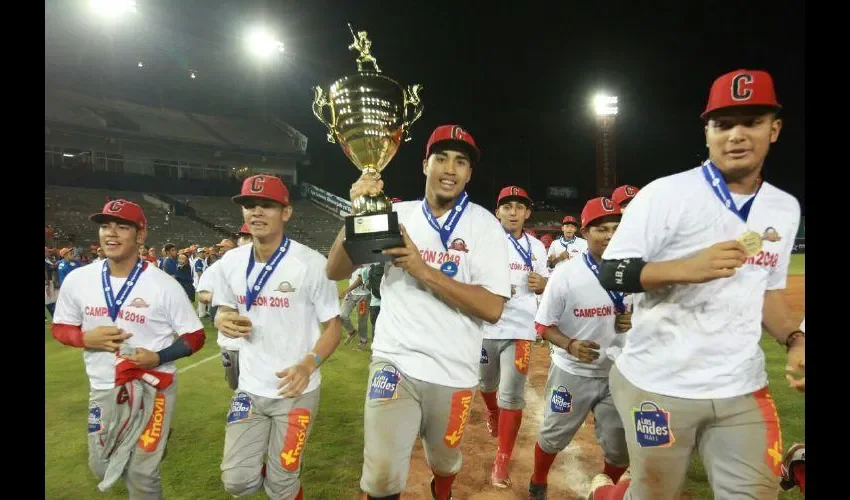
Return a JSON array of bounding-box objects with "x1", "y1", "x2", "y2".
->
[{"x1": 52, "y1": 70, "x2": 805, "y2": 500}]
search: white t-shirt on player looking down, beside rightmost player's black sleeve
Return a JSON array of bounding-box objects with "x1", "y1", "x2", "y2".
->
[{"x1": 535, "y1": 255, "x2": 630, "y2": 377}]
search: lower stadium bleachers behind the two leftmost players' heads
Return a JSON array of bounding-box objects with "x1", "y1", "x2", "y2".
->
[{"x1": 44, "y1": 186, "x2": 342, "y2": 255}]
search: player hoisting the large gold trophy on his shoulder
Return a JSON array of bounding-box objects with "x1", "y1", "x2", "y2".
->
[{"x1": 328, "y1": 125, "x2": 510, "y2": 500}]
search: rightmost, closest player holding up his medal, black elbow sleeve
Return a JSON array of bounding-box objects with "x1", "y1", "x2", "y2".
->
[{"x1": 593, "y1": 70, "x2": 805, "y2": 500}]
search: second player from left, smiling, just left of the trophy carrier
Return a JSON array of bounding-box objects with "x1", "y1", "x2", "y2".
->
[{"x1": 213, "y1": 174, "x2": 341, "y2": 500}]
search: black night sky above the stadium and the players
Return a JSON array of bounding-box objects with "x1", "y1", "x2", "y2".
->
[{"x1": 45, "y1": 0, "x2": 805, "y2": 213}]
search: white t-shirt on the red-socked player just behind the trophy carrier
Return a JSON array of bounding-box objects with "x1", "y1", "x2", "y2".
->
[{"x1": 484, "y1": 233, "x2": 549, "y2": 340}]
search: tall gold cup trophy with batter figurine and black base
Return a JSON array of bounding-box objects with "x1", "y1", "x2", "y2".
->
[{"x1": 313, "y1": 23, "x2": 422, "y2": 264}]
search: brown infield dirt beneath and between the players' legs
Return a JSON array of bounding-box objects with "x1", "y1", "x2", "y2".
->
[{"x1": 402, "y1": 275, "x2": 806, "y2": 500}]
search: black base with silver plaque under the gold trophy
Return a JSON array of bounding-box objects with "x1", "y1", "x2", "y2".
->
[{"x1": 342, "y1": 212, "x2": 404, "y2": 265}]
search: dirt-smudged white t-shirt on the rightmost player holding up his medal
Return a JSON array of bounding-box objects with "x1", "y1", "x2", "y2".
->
[{"x1": 603, "y1": 167, "x2": 800, "y2": 399}]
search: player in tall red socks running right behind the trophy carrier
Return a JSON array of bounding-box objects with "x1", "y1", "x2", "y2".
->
[{"x1": 478, "y1": 186, "x2": 549, "y2": 488}]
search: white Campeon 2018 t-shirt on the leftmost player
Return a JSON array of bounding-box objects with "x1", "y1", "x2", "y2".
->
[{"x1": 53, "y1": 263, "x2": 204, "y2": 390}]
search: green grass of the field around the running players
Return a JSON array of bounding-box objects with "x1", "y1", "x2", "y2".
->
[{"x1": 44, "y1": 255, "x2": 805, "y2": 500}]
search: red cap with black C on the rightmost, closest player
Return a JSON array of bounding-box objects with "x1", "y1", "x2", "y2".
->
[{"x1": 700, "y1": 69, "x2": 782, "y2": 119}]
